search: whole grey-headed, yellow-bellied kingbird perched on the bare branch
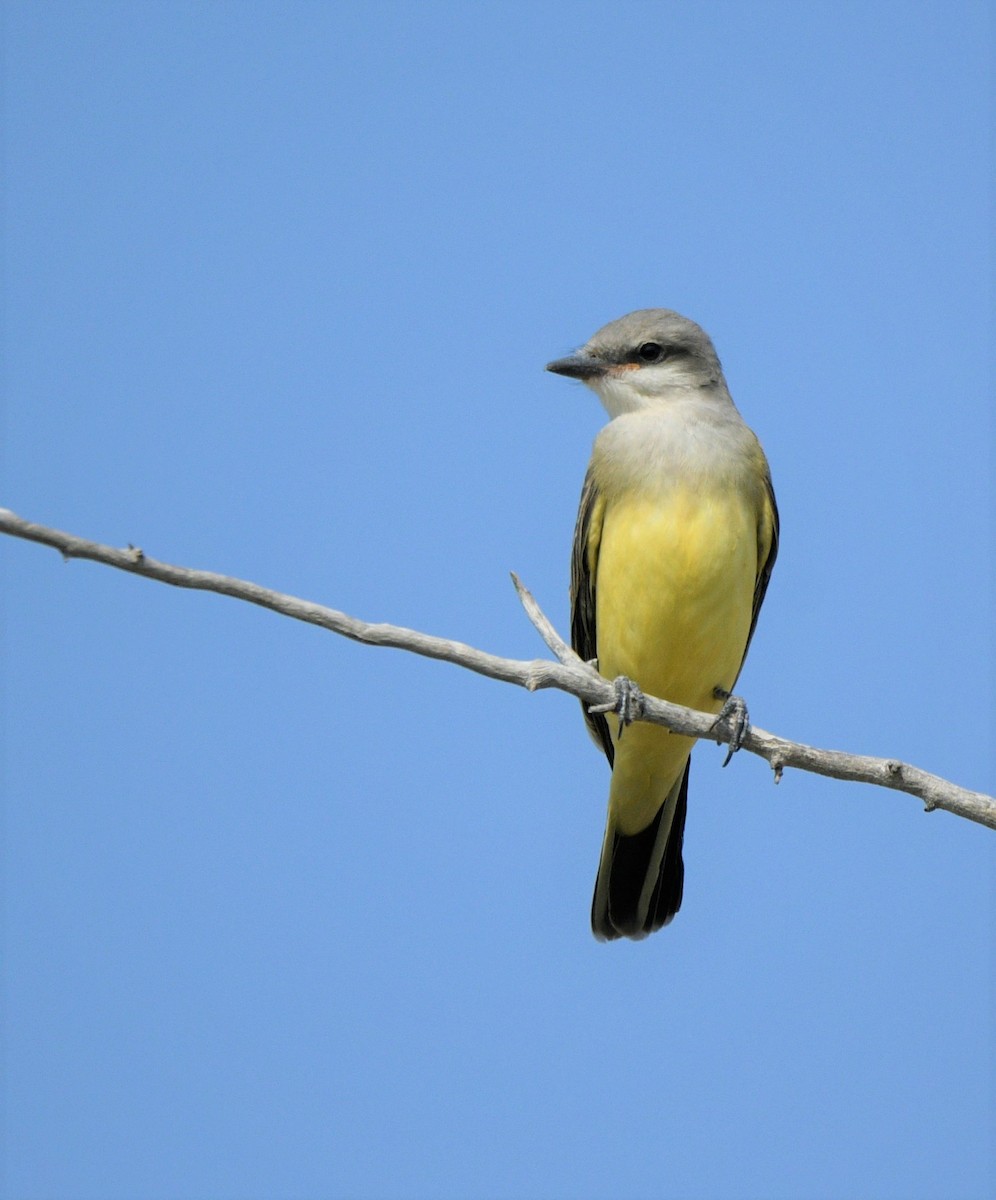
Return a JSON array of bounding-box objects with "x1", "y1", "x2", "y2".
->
[{"x1": 547, "y1": 308, "x2": 779, "y2": 940}]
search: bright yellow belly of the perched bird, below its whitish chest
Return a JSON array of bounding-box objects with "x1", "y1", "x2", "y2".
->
[{"x1": 595, "y1": 490, "x2": 757, "y2": 834}]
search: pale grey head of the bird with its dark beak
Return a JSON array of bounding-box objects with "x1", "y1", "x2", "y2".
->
[{"x1": 546, "y1": 308, "x2": 726, "y2": 416}]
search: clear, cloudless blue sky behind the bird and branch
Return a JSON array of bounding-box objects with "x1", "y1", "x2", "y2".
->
[{"x1": 0, "y1": 7, "x2": 996, "y2": 1200}]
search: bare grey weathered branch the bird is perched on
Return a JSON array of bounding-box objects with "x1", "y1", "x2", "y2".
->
[{"x1": 0, "y1": 509, "x2": 996, "y2": 829}]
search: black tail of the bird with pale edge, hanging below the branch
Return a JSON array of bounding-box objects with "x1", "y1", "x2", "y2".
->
[{"x1": 592, "y1": 760, "x2": 691, "y2": 941}]
